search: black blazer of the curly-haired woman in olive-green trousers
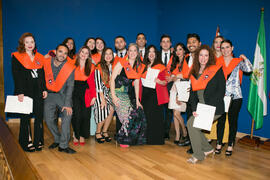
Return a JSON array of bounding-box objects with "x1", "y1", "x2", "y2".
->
[{"x1": 189, "y1": 68, "x2": 226, "y2": 115}]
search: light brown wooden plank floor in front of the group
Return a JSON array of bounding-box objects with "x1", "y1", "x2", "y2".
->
[{"x1": 6, "y1": 123, "x2": 270, "y2": 180}]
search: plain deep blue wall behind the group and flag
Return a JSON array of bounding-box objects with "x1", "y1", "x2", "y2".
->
[{"x1": 2, "y1": 0, "x2": 270, "y2": 138}]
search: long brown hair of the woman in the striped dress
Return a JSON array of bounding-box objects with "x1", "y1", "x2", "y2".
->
[{"x1": 98, "y1": 47, "x2": 114, "y2": 83}]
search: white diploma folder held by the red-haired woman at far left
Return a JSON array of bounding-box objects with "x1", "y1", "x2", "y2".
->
[{"x1": 5, "y1": 96, "x2": 33, "y2": 114}]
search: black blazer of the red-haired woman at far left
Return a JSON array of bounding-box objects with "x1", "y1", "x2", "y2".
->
[{"x1": 12, "y1": 56, "x2": 46, "y2": 98}]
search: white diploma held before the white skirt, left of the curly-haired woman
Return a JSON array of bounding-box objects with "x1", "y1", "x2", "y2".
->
[{"x1": 175, "y1": 80, "x2": 190, "y2": 102}]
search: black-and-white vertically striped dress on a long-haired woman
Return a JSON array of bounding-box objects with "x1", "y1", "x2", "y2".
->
[{"x1": 94, "y1": 65, "x2": 112, "y2": 123}]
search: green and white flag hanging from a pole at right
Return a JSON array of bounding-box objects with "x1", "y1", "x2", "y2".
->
[{"x1": 248, "y1": 10, "x2": 267, "y2": 129}]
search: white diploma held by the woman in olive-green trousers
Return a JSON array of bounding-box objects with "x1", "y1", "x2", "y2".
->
[{"x1": 193, "y1": 103, "x2": 216, "y2": 131}]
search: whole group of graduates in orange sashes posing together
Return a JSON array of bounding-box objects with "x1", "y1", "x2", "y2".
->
[{"x1": 12, "y1": 33, "x2": 252, "y2": 163}]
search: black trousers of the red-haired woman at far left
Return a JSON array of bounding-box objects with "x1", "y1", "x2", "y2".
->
[{"x1": 19, "y1": 93, "x2": 44, "y2": 150}]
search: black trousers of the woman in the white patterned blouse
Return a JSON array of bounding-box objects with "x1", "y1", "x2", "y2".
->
[{"x1": 217, "y1": 98, "x2": 243, "y2": 146}]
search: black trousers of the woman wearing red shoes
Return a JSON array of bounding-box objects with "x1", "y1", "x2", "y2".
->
[{"x1": 71, "y1": 81, "x2": 91, "y2": 139}]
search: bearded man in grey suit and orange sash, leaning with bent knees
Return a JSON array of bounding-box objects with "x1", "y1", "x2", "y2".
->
[{"x1": 44, "y1": 44, "x2": 76, "y2": 154}]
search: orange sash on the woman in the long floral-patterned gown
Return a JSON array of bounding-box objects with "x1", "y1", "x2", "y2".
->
[{"x1": 119, "y1": 58, "x2": 145, "y2": 79}]
